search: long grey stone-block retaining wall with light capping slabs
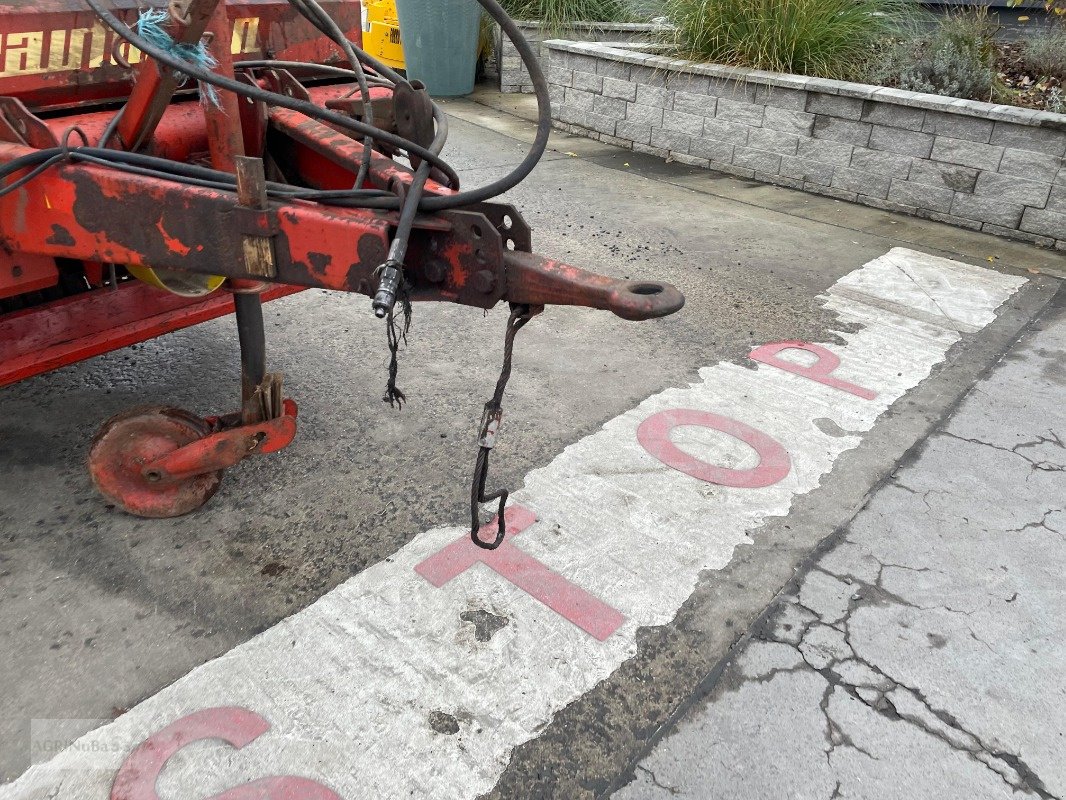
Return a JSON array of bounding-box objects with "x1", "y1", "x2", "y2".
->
[{"x1": 545, "y1": 41, "x2": 1066, "y2": 251}]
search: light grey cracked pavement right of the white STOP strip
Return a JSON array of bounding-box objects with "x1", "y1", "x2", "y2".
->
[{"x1": 615, "y1": 294, "x2": 1066, "y2": 800}]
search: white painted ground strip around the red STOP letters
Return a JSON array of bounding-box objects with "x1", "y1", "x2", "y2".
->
[{"x1": 6, "y1": 249, "x2": 1024, "y2": 800}]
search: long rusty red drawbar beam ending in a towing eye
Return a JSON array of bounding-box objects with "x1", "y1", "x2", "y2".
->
[{"x1": 0, "y1": 143, "x2": 682, "y2": 320}]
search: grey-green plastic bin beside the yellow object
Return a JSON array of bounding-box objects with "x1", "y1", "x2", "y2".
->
[{"x1": 397, "y1": 0, "x2": 481, "y2": 97}]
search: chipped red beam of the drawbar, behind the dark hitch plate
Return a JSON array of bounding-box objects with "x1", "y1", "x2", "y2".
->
[{"x1": 0, "y1": 137, "x2": 390, "y2": 291}]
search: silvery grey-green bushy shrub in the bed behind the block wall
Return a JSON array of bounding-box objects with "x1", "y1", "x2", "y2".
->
[{"x1": 868, "y1": 7, "x2": 1003, "y2": 100}]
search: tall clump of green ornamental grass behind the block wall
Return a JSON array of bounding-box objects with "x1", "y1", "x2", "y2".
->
[{"x1": 666, "y1": 0, "x2": 914, "y2": 79}]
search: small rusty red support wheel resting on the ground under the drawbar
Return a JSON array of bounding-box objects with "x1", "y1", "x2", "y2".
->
[{"x1": 88, "y1": 405, "x2": 222, "y2": 518}]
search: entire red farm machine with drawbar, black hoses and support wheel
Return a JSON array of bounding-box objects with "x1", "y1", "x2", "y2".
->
[{"x1": 0, "y1": 0, "x2": 683, "y2": 539}]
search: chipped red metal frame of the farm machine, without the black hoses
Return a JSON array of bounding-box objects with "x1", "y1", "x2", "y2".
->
[{"x1": 0, "y1": 0, "x2": 683, "y2": 516}]
